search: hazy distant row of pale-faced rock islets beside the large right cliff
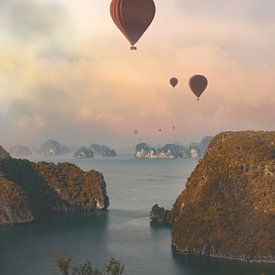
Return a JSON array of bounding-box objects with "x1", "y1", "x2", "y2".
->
[{"x1": 135, "y1": 136, "x2": 212, "y2": 159}]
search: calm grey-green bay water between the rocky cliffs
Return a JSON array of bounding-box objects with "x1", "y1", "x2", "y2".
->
[{"x1": 0, "y1": 156, "x2": 275, "y2": 275}]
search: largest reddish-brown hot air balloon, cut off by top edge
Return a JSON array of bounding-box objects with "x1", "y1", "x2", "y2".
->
[{"x1": 110, "y1": 0, "x2": 156, "y2": 50}]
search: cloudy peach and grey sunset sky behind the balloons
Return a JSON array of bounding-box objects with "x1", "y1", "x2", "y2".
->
[{"x1": 0, "y1": 0, "x2": 275, "y2": 147}]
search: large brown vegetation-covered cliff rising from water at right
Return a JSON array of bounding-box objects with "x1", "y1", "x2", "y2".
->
[{"x1": 172, "y1": 132, "x2": 275, "y2": 262}]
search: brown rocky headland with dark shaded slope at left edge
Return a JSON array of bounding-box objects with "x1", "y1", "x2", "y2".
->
[{"x1": 0, "y1": 147, "x2": 109, "y2": 225}]
